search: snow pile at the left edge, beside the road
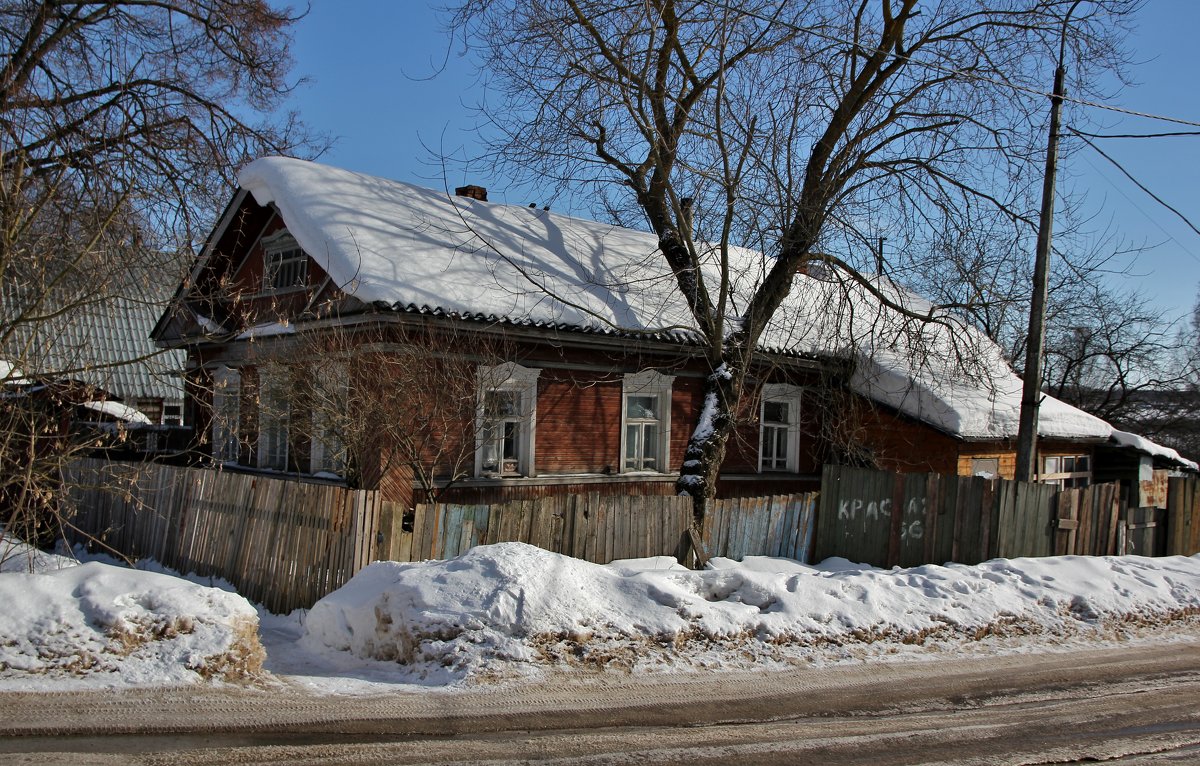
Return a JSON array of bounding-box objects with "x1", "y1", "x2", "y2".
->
[{"x1": 0, "y1": 538, "x2": 264, "y2": 688}]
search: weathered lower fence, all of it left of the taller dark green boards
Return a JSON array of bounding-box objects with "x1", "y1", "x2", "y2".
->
[{"x1": 64, "y1": 460, "x2": 817, "y2": 614}]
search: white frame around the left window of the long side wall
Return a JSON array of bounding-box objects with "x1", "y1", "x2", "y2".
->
[{"x1": 475, "y1": 361, "x2": 541, "y2": 478}]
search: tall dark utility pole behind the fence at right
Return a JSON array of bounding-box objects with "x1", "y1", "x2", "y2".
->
[{"x1": 1016, "y1": 0, "x2": 1082, "y2": 481}]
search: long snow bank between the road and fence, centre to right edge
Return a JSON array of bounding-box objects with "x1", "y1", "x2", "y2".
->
[{"x1": 302, "y1": 543, "x2": 1200, "y2": 677}]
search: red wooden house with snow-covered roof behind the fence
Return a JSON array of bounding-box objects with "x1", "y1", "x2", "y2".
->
[{"x1": 152, "y1": 157, "x2": 1195, "y2": 502}]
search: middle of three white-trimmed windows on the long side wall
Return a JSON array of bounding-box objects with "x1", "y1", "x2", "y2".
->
[{"x1": 620, "y1": 370, "x2": 674, "y2": 473}]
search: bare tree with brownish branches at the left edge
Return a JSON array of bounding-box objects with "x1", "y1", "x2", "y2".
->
[{"x1": 0, "y1": 0, "x2": 317, "y2": 557}]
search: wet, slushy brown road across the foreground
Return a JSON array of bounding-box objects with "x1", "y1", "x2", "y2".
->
[{"x1": 0, "y1": 642, "x2": 1200, "y2": 766}]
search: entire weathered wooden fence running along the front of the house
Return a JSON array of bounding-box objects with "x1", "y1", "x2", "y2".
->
[{"x1": 64, "y1": 460, "x2": 1200, "y2": 612}]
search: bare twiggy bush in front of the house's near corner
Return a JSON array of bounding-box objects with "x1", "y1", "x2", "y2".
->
[{"x1": 251, "y1": 322, "x2": 506, "y2": 502}]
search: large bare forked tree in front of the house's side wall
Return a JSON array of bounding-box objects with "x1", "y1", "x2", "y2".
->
[{"x1": 452, "y1": 0, "x2": 1134, "y2": 523}]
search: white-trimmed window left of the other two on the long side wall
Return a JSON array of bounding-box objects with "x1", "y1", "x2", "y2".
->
[{"x1": 475, "y1": 361, "x2": 541, "y2": 477}]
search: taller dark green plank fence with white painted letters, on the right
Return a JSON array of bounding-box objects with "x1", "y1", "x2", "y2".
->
[{"x1": 816, "y1": 466, "x2": 1185, "y2": 567}]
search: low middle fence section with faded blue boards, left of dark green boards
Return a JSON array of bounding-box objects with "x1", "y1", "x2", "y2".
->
[{"x1": 384, "y1": 492, "x2": 817, "y2": 563}]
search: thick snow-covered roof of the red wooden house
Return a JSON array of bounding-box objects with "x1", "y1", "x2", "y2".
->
[{"x1": 239, "y1": 157, "x2": 1112, "y2": 441}]
